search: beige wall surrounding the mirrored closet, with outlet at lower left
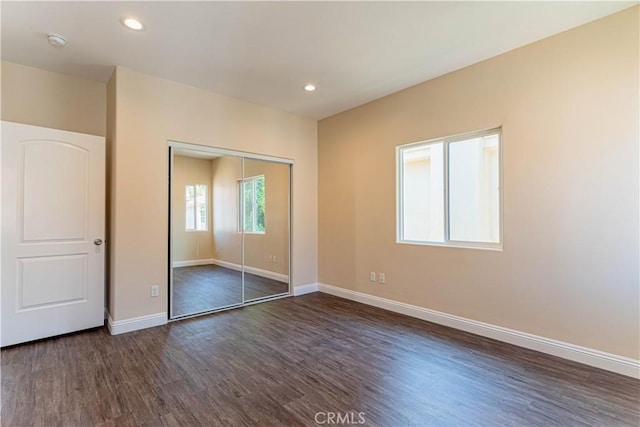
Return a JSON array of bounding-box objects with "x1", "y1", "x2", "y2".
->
[{"x1": 109, "y1": 67, "x2": 317, "y2": 321}]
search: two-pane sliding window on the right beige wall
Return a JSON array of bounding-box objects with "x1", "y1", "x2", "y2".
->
[{"x1": 396, "y1": 129, "x2": 502, "y2": 248}]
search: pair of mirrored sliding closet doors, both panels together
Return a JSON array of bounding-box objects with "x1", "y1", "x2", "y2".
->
[{"x1": 169, "y1": 143, "x2": 291, "y2": 319}]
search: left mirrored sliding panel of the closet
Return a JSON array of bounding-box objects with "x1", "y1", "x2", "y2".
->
[{"x1": 171, "y1": 151, "x2": 243, "y2": 317}]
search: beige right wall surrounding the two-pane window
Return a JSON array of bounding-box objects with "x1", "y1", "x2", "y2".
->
[{"x1": 318, "y1": 7, "x2": 640, "y2": 359}]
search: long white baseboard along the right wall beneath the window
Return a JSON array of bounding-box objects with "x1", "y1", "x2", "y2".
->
[{"x1": 316, "y1": 283, "x2": 640, "y2": 378}]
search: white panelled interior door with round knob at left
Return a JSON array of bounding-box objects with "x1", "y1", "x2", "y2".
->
[{"x1": 0, "y1": 122, "x2": 105, "y2": 346}]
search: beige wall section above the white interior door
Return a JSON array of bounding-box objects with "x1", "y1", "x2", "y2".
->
[{"x1": 1, "y1": 61, "x2": 107, "y2": 136}]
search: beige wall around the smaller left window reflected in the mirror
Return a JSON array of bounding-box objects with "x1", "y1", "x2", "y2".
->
[{"x1": 171, "y1": 156, "x2": 213, "y2": 262}]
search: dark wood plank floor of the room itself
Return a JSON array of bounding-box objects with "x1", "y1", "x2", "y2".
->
[{"x1": 1, "y1": 293, "x2": 640, "y2": 426}]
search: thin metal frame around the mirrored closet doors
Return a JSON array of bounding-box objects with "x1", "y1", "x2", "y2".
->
[{"x1": 167, "y1": 140, "x2": 294, "y2": 322}]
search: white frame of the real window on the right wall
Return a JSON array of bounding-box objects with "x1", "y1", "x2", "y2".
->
[{"x1": 396, "y1": 127, "x2": 504, "y2": 251}]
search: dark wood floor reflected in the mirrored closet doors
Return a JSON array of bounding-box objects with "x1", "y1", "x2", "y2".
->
[{"x1": 173, "y1": 264, "x2": 289, "y2": 317}]
